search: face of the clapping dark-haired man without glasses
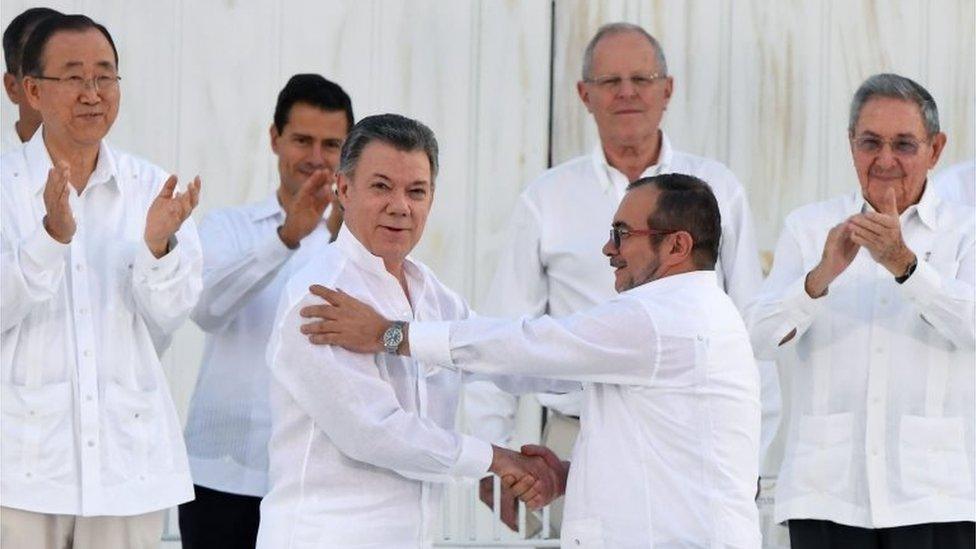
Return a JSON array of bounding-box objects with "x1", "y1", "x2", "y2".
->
[{"x1": 270, "y1": 103, "x2": 349, "y2": 196}]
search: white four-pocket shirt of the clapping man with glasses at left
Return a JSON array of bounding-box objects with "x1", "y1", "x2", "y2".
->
[{"x1": 0, "y1": 128, "x2": 202, "y2": 516}]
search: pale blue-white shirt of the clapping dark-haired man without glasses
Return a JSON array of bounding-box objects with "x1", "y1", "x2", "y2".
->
[{"x1": 185, "y1": 194, "x2": 331, "y2": 497}]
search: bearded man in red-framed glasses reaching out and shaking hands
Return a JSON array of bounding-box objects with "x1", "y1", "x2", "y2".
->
[{"x1": 302, "y1": 174, "x2": 760, "y2": 548}]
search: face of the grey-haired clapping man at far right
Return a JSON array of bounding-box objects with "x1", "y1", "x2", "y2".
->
[{"x1": 851, "y1": 97, "x2": 946, "y2": 212}]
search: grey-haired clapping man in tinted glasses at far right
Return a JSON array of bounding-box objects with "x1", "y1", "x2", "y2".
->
[{"x1": 750, "y1": 74, "x2": 976, "y2": 549}]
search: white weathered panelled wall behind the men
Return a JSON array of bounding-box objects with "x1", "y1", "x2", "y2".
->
[{"x1": 0, "y1": 0, "x2": 976, "y2": 432}]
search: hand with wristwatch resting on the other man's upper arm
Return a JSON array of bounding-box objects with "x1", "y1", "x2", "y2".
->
[{"x1": 299, "y1": 284, "x2": 390, "y2": 354}]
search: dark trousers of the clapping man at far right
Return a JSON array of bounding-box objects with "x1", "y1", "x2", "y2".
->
[{"x1": 789, "y1": 520, "x2": 976, "y2": 549}]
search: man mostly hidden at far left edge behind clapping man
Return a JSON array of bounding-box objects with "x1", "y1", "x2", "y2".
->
[{"x1": 0, "y1": 8, "x2": 61, "y2": 153}]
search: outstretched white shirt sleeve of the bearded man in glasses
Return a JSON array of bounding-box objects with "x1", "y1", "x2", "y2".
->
[{"x1": 409, "y1": 299, "x2": 662, "y2": 385}]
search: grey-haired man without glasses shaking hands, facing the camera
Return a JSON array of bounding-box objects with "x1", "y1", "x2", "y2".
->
[{"x1": 258, "y1": 114, "x2": 578, "y2": 549}]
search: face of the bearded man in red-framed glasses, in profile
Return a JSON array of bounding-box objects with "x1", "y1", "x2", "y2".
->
[{"x1": 603, "y1": 186, "x2": 667, "y2": 292}]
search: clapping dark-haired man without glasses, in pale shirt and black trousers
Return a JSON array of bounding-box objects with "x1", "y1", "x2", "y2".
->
[{"x1": 180, "y1": 74, "x2": 353, "y2": 549}]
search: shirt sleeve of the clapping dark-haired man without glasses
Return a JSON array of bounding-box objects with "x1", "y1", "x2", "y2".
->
[{"x1": 191, "y1": 212, "x2": 295, "y2": 332}]
